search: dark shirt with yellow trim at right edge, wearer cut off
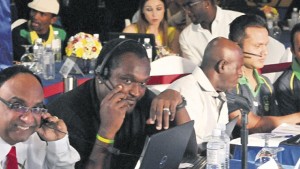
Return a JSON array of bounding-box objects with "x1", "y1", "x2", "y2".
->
[{"x1": 274, "y1": 58, "x2": 300, "y2": 115}]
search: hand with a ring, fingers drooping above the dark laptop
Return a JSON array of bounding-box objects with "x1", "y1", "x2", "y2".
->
[{"x1": 147, "y1": 89, "x2": 183, "y2": 130}]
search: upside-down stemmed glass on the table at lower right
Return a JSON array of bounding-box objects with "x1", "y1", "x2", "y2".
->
[{"x1": 255, "y1": 133, "x2": 284, "y2": 169}]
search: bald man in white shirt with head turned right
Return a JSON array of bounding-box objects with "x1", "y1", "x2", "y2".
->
[{"x1": 152, "y1": 37, "x2": 243, "y2": 144}]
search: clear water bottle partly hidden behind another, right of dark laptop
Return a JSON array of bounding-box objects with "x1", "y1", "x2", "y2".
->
[{"x1": 217, "y1": 123, "x2": 230, "y2": 169}]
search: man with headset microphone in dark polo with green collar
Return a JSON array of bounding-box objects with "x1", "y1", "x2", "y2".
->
[{"x1": 226, "y1": 15, "x2": 300, "y2": 137}]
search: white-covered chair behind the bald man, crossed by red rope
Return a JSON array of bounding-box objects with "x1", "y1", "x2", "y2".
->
[{"x1": 147, "y1": 56, "x2": 197, "y2": 94}]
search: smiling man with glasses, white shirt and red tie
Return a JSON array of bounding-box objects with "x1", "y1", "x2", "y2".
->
[{"x1": 0, "y1": 66, "x2": 80, "y2": 169}]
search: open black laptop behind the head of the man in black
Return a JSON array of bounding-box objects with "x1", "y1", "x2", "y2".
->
[{"x1": 108, "y1": 32, "x2": 156, "y2": 60}]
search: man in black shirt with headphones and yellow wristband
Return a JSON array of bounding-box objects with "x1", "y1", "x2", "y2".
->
[{"x1": 48, "y1": 39, "x2": 190, "y2": 169}]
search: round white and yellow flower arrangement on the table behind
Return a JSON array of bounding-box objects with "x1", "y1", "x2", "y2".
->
[{"x1": 66, "y1": 32, "x2": 102, "y2": 59}]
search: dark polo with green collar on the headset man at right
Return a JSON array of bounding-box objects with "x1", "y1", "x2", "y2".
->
[{"x1": 226, "y1": 70, "x2": 280, "y2": 116}]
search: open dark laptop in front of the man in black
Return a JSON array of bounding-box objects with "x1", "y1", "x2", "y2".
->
[{"x1": 135, "y1": 121, "x2": 194, "y2": 169}]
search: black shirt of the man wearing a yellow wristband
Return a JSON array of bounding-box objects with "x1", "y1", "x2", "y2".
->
[{"x1": 48, "y1": 79, "x2": 156, "y2": 169}]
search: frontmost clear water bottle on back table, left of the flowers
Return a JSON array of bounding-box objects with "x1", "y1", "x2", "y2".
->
[{"x1": 42, "y1": 44, "x2": 55, "y2": 80}]
